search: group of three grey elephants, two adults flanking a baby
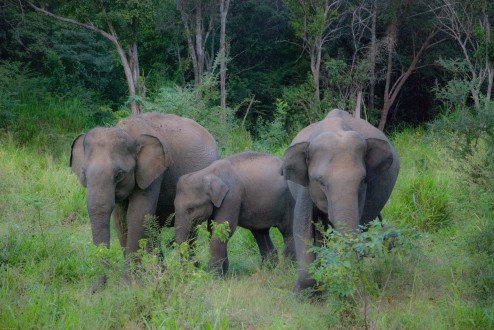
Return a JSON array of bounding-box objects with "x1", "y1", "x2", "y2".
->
[{"x1": 70, "y1": 109, "x2": 399, "y2": 292}]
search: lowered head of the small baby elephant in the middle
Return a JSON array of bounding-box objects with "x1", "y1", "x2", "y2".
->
[{"x1": 174, "y1": 171, "x2": 229, "y2": 244}]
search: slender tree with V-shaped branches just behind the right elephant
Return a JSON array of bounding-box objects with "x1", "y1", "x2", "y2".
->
[{"x1": 286, "y1": 0, "x2": 343, "y2": 102}]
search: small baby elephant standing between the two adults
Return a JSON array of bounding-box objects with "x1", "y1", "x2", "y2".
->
[{"x1": 175, "y1": 152, "x2": 294, "y2": 274}]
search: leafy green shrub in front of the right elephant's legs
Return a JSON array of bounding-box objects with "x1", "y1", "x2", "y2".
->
[{"x1": 309, "y1": 221, "x2": 404, "y2": 327}]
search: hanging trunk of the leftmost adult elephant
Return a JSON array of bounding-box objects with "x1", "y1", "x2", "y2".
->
[{"x1": 86, "y1": 182, "x2": 115, "y2": 248}]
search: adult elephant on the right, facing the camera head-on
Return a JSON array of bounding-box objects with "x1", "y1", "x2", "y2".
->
[{"x1": 283, "y1": 109, "x2": 400, "y2": 292}]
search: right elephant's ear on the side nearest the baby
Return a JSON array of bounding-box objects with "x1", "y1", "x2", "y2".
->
[{"x1": 282, "y1": 142, "x2": 309, "y2": 187}]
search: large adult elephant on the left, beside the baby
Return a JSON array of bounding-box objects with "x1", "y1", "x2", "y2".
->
[{"x1": 70, "y1": 113, "x2": 219, "y2": 284}]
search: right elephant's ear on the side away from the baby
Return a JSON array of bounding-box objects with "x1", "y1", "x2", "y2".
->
[{"x1": 365, "y1": 139, "x2": 393, "y2": 177}]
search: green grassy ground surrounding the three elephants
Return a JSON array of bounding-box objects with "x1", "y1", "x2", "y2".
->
[{"x1": 0, "y1": 96, "x2": 494, "y2": 329}]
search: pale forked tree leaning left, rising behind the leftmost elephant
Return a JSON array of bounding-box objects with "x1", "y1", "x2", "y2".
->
[{"x1": 27, "y1": 0, "x2": 155, "y2": 114}]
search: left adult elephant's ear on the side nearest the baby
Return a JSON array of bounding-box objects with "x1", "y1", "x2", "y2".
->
[{"x1": 136, "y1": 134, "x2": 172, "y2": 190}]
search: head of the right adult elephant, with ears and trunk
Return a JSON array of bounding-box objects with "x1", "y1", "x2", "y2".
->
[{"x1": 283, "y1": 131, "x2": 393, "y2": 231}]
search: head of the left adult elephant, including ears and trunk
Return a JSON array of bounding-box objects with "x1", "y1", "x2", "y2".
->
[{"x1": 70, "y1": 127, "x2": 171, "y2": 247}]
